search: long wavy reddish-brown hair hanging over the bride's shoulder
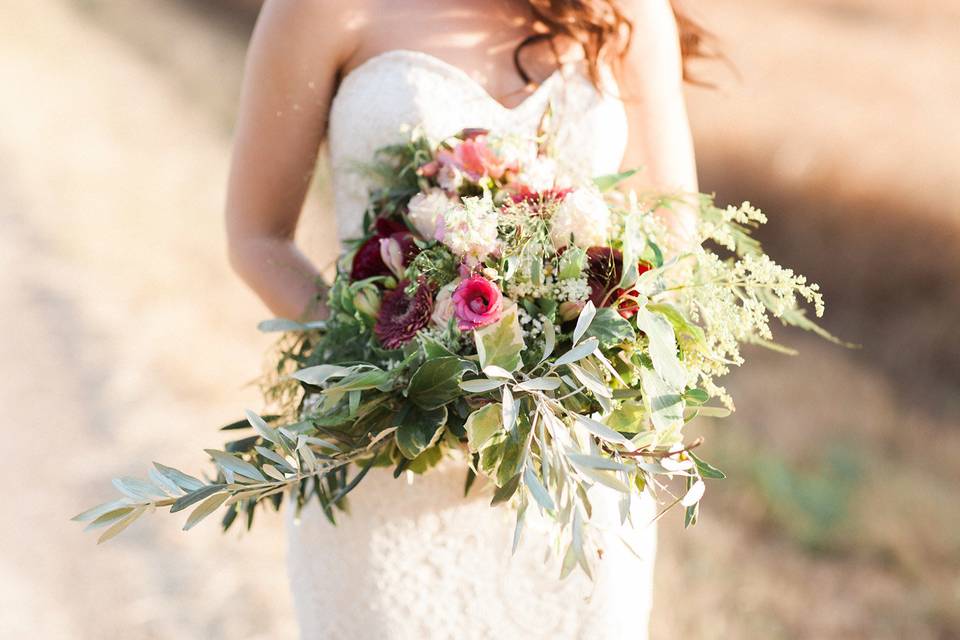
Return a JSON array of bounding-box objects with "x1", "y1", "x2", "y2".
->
[{"x1": 513, "y1": 0, "x2": 709, "y2": 87}]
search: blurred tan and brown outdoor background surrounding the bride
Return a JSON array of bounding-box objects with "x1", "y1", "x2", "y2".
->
[{"x1": 0, "y1": 0, "x2": 960, "y2": 640}]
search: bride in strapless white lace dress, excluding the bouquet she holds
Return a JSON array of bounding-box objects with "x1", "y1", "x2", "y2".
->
[{"x1": 227, "y1": 0, "x2": 698, "y2": 640}]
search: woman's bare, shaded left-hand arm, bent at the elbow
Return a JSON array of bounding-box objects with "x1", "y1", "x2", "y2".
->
[{"x1": 226, "y1": 0, "x2": 360, "y2": 319}]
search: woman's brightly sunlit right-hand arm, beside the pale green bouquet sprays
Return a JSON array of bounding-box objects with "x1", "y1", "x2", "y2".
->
[{"x1": 618, "y1": 0, "x2": 698, "y2": 244}]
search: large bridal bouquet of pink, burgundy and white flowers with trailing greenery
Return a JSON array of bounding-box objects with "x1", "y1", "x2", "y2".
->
[{"x1": 76, "y1": 125, "x2": 829, "y2": 574}]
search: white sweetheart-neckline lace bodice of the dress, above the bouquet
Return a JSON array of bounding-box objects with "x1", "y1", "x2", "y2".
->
[{"x1": 329, "y1": 49, "x2": 627, "y2": 239}]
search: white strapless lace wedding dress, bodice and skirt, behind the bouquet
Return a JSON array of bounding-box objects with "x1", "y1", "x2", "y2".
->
[{"x1": 288, "y1": 50, "x2": 656, "y2": 640}]
